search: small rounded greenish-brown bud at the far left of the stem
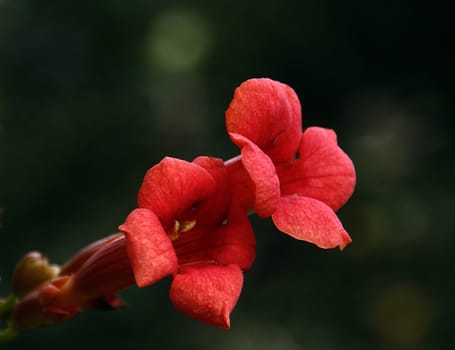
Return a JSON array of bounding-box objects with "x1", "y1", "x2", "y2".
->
[{"x1": 13, "y1": 251, "x2": 60, "y2": 296}]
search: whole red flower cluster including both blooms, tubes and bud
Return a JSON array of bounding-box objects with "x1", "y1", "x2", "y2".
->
[{"x1": 0, "y1": 78, "x2": 356, "y2": 340}]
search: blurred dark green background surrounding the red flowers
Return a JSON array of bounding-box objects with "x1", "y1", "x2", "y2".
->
[{"x1": 0, "y1": 0, "x2": 455, "y2": 350}]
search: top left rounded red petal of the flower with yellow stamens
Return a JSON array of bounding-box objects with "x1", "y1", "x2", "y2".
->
[{"x1": 138, "y1": 157, "x2": 216, "y2": 228}]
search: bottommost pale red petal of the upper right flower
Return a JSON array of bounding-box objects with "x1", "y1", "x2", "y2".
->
[{"x1": 272, "y1": 196, "x2": 351, "y2": 249}]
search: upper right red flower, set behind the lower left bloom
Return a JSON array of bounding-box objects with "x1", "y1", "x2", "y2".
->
[{"x1": 226, "y1": 79, "x2": 355, "y2": 249}]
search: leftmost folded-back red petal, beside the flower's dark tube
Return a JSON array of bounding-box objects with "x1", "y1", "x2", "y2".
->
[{"x1": 119, "y1": 209, "x2": 177, "y2": 287}]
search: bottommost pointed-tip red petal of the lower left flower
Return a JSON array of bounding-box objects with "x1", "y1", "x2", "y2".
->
[{"x1": 169, "y1": 265, "x2": 243, "y2": 328}]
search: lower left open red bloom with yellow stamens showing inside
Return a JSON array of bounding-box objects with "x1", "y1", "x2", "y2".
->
[{"x1": 120, "y1": 157, "x2": 255, "y2": 328}]
